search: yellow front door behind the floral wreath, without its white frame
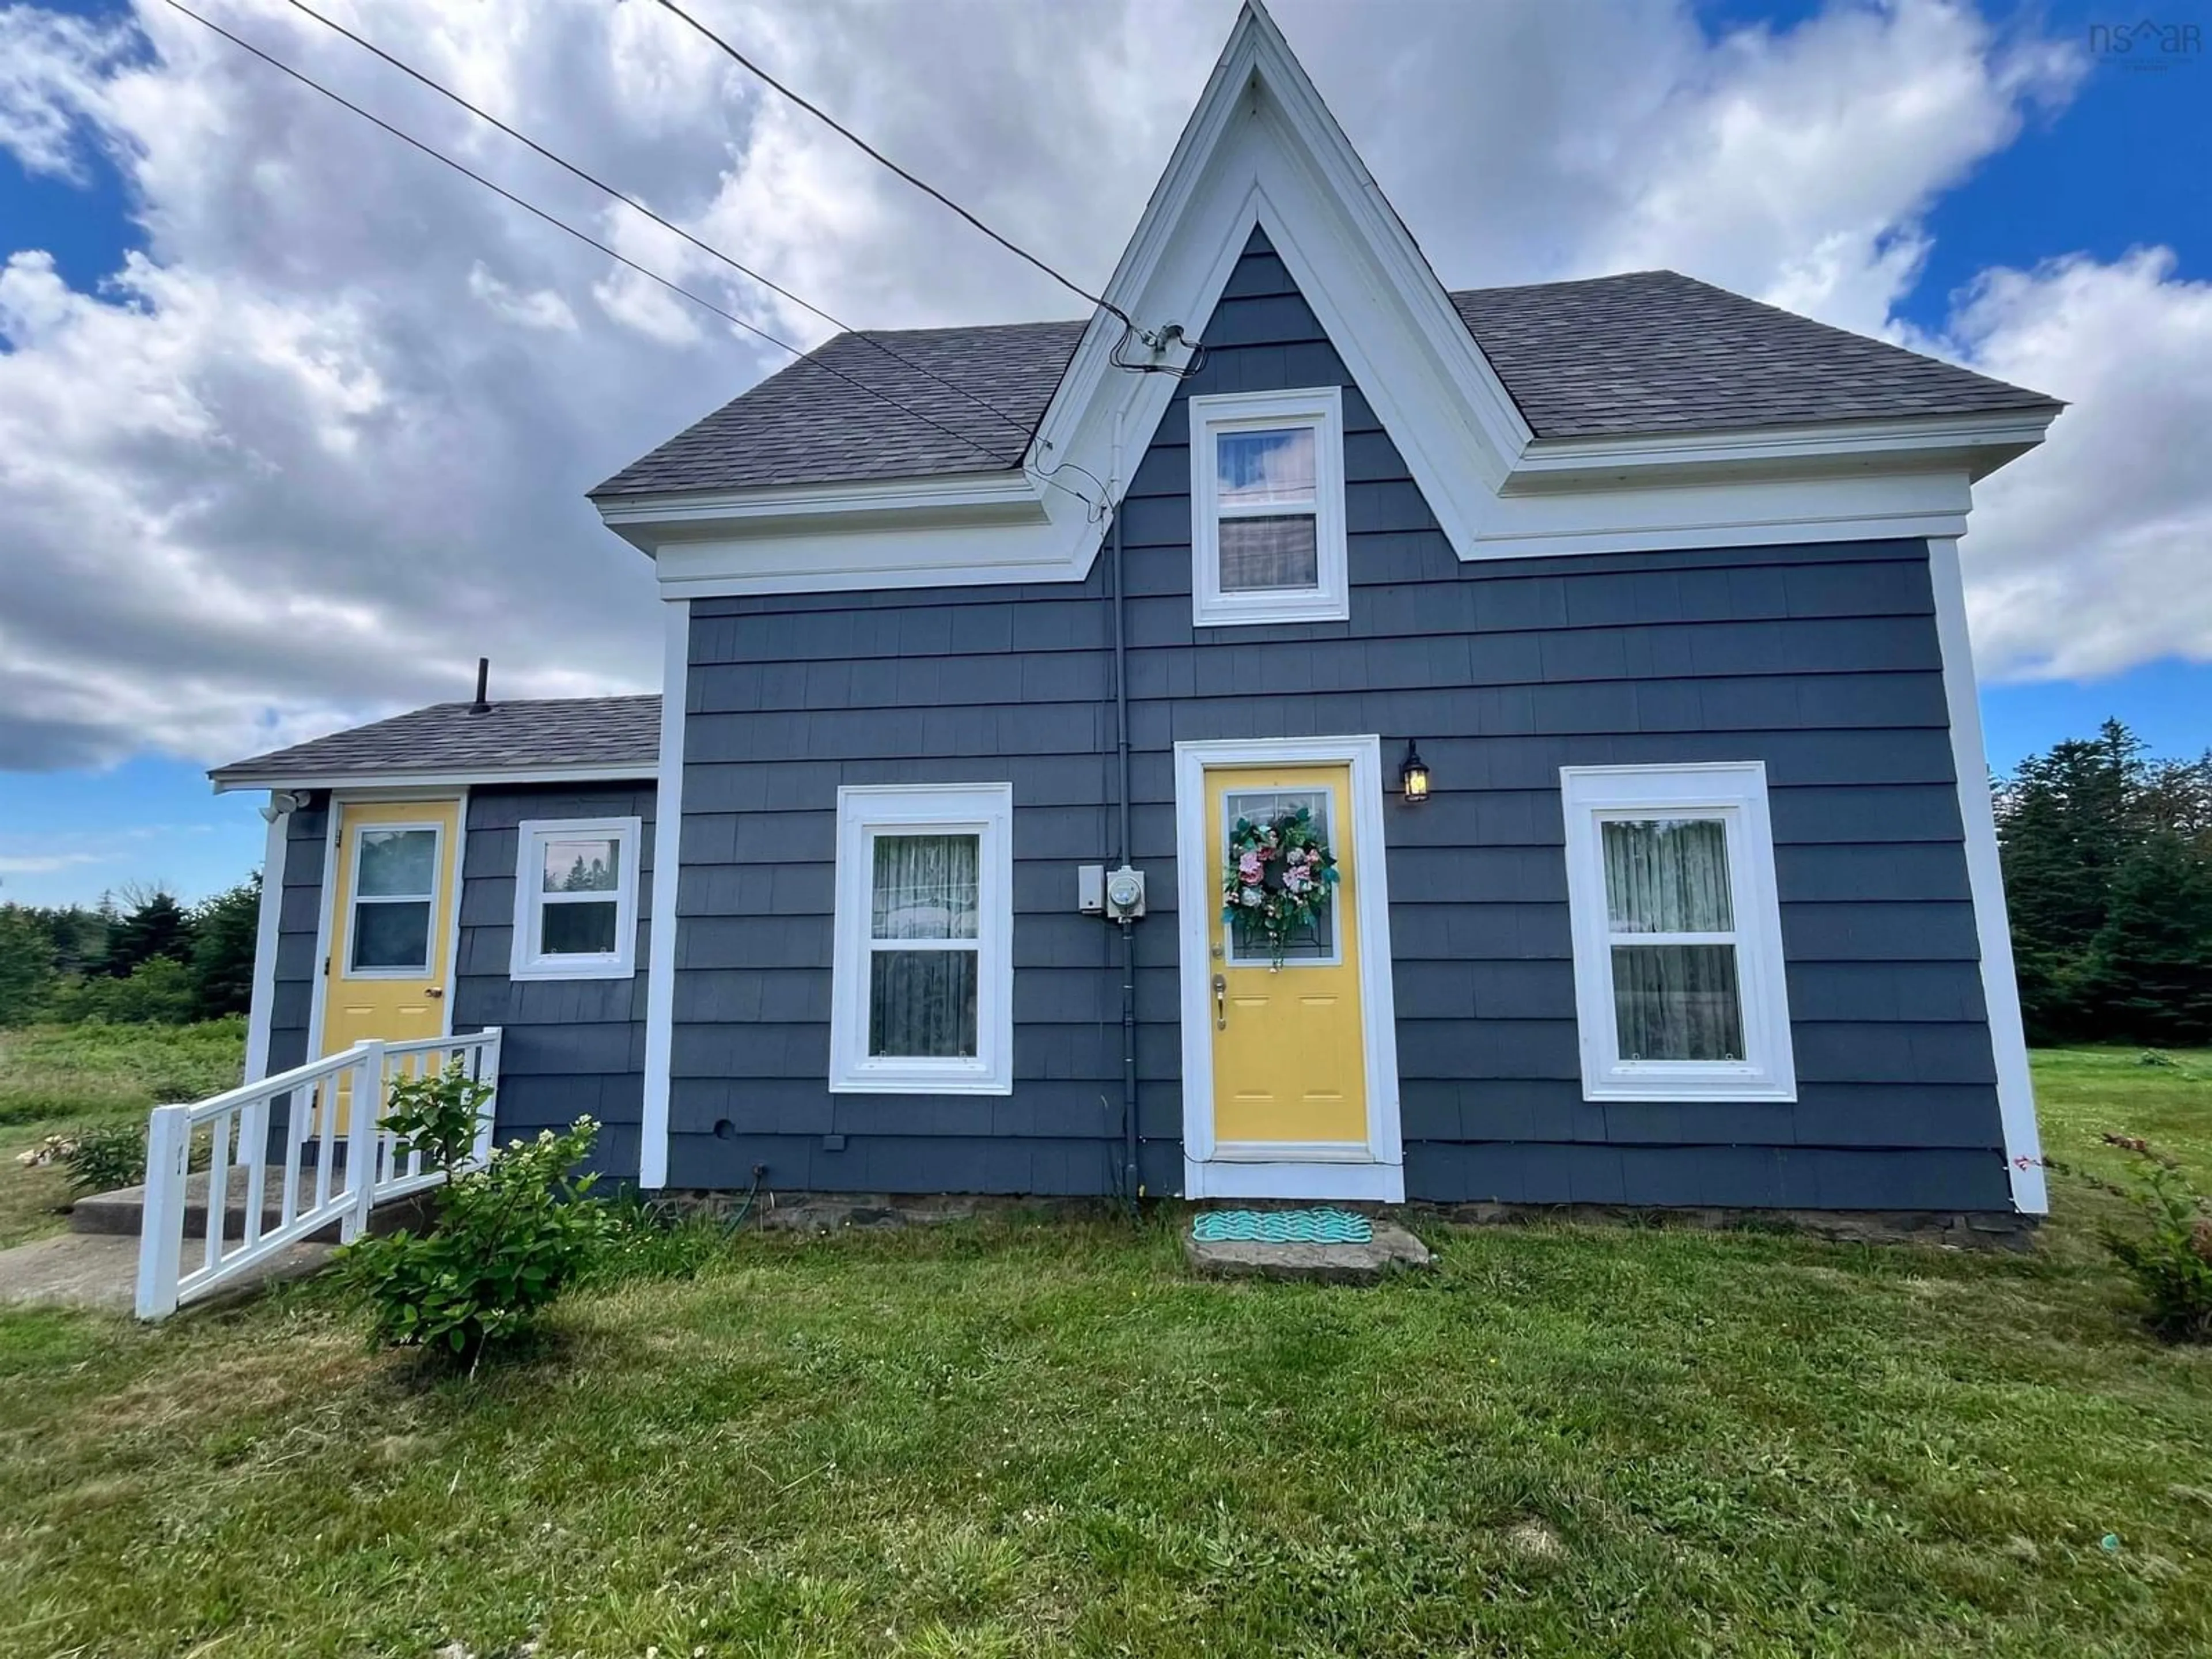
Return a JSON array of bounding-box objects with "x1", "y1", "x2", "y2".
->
[{"x1": 1206, "y1": 763, "x2": 1367, "y2": 1157}]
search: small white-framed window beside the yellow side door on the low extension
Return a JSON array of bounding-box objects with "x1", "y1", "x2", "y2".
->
[{"x1": 509, "y1": 819, "x2": 642, "y2": 980}]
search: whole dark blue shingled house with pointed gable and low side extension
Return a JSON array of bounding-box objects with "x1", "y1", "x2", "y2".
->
[{"x1": 214, "y1": 7, "x2": 2059, "y2": 1217}]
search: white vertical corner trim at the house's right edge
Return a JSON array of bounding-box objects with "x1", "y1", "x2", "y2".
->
[{"x1": 1929, "y1": 537, "x2": 2051, "y2": 1214}]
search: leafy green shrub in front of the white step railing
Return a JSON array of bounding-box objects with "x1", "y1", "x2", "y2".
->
[{"x1": 343, "y1": 1071, "x2": 615, "y2": 1365}]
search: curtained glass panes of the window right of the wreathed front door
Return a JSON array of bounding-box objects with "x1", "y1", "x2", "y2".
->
[{"x1": 1601, "y1": 819, "x2": 1743, "y2": 1059}]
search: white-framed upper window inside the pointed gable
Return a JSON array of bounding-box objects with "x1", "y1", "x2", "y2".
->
[{"x1": 1190, "y1": 387, "x2": 1351, "y2": 628}]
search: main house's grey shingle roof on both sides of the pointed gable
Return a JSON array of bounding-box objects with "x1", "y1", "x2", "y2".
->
[{"x1": 590, "y1": 270, "x2": 2057, "y2": 500}]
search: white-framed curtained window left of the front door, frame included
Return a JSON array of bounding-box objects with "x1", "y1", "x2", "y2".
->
[{"x1": 830, "y1": 783, "x2": 1013, "y2": 1095}]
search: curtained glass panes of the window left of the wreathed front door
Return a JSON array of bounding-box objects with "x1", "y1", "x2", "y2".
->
[{"x1": 867, "y1": 836, "x2": 982, "y2": 1059}]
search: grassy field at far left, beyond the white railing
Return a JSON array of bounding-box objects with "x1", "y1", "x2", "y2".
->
[{"x1": 0, "y1": 1020, "x2": 245, "y2": 1248}]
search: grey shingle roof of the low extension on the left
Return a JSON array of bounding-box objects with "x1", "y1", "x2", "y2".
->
[{"x1": 208, "y1": 695, "x2": 661, "y2": 783}]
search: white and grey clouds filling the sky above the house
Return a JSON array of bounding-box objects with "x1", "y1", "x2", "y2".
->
[{"x1": 0, "y1": 0, "x2": 2212, "y2": 767}]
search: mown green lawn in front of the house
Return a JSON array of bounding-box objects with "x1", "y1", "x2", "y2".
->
[{"x1": 0, "y1": 1051, "x2": 2212, "y2": 1659}]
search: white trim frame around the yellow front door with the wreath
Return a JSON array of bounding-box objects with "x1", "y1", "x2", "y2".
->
[{"x1": 1175, "y1": 734, "x2": 1404, "y2": 1203}]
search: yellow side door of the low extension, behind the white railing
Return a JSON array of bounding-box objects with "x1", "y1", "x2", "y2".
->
[{"x1": 323, "y1": 801, "x2": 460, "y2": 1110}]
